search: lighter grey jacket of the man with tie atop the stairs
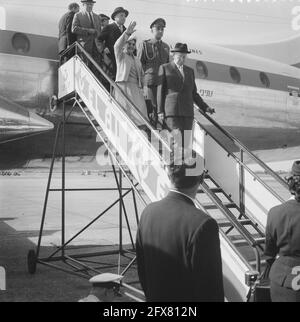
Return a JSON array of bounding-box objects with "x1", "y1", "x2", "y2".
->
[{"x1": 72, "y1": 11, "x2": 101, "y2": 54}]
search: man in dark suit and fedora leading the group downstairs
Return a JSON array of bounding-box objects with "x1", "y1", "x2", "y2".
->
[{"x1": 157, "y1": 43, "x2": 214, "y2": 150}]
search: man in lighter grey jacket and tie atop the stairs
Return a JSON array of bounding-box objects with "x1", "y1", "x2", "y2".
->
[{"x1": 72, "y1": 0, "x2": 101, "y2": 59}]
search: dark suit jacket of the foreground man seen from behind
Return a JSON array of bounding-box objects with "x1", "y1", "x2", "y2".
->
[{"x1": 136, "y1": 192, "x2": 224, "y2": 302}]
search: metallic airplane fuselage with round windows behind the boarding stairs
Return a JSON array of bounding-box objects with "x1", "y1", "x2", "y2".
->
[{"x1": 0, "y1": 31, "x2": 300, "y2": 168}]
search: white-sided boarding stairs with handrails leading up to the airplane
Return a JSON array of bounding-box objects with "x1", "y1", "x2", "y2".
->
[{"x1": 55, "y1": 44, "x2": 287, "y2": 301}]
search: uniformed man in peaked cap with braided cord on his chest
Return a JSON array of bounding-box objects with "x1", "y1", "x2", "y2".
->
[{"x1": 138, "y1": 18, "x2": 170, "y2": 127}]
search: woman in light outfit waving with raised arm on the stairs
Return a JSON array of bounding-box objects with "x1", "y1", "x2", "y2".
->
[{"x1": 114, "y1": 22, "x2": 148, "y2": 126}]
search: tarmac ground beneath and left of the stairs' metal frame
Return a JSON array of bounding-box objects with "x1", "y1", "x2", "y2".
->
[{"x1": 0, "y1": 171, "x2": 141, "y2": 302}]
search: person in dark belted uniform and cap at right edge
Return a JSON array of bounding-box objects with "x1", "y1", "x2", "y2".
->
[{"x1": 265, "y1": 161, "x2": 300, "y2": 302}]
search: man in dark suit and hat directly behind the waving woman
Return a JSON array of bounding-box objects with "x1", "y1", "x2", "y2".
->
[{"x1": 98, "y1": 7, "x2": 129, "y2": 78}]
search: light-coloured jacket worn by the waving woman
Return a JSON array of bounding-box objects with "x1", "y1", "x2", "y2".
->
[{"x1": 114, "y1": 32, "x2": 143, "y2": 88}]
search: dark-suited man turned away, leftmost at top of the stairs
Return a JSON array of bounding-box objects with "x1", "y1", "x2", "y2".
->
[{"x1": 58, "y1": 2, "x2": 79, "y2": 53}]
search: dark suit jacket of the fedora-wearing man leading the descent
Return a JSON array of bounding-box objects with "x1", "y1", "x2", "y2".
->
[{"x1": 157, "y1": 62, "x2": 208, "y2": 117}]
